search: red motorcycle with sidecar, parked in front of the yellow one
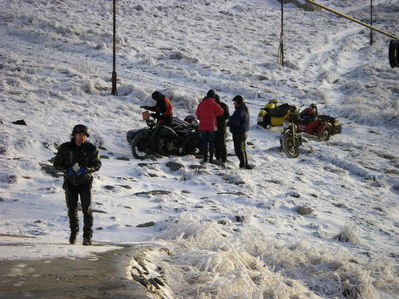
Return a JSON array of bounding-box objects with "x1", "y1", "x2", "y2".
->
[{"x1": 280, "y1": 104, "x2": 342, "y2": 158}]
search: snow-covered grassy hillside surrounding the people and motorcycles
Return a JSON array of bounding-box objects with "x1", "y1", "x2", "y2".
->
[{"x1": 0, "y1": 0, "x2": 399, "y2": 298}]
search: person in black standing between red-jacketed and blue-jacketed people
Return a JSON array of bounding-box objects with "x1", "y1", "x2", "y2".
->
[{"x1": 215, "y1": 94, "x2": 230, "y2": 163}]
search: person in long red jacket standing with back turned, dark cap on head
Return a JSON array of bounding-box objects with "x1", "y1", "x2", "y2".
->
[{"x1": 196, "y1": 89, "x2": 224, "y2": 163}]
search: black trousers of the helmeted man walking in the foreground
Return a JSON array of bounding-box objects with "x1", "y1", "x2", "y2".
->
[{"x1": 64, "y1": 182, "x2": 93, "y2": 237}]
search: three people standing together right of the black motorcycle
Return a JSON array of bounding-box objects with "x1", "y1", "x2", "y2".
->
[{"x1": 196, "y1": 89, "x2": 251, "y2": 169}]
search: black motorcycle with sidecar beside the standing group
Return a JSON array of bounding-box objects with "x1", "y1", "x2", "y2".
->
[{"x1": 126, "y1": 111, "x2": 200, "y2": 159}]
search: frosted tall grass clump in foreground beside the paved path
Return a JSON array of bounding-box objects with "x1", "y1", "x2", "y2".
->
[{"x1": 129, "y1": 213, "x2": 399, "y2": 298}]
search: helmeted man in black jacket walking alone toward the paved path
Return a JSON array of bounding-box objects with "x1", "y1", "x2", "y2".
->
[{"x1": 54, "y1": 124, "x2": 101, "y2": 245}]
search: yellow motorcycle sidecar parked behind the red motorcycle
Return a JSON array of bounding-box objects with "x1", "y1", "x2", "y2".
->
[{"x1": 258, "y1": 99, "x2": 299, "y2": 129}]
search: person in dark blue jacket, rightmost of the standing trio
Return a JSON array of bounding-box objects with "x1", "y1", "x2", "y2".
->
[{"x1": 227, "y1": 95, "x2": 251, "y2": 169}]
